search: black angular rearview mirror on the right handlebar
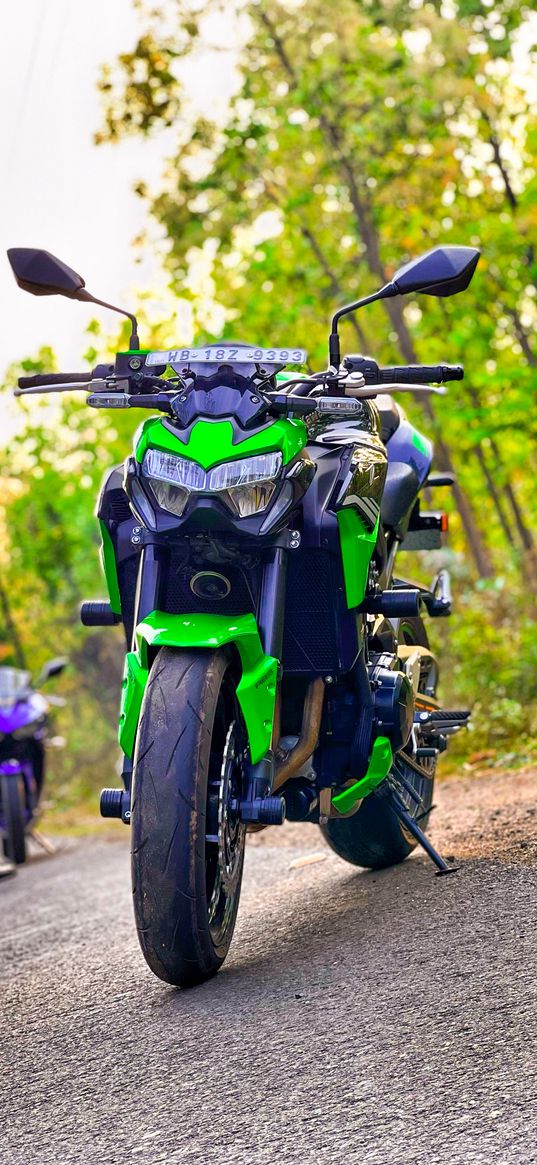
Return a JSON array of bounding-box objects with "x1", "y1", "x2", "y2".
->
[{"x1": 391, "y1": 247, "x2": 479, "y2": 296}]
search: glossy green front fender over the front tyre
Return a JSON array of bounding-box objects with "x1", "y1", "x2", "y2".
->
[{"x1": 119, "y1": 610, "x2": 278, "y2": 764}]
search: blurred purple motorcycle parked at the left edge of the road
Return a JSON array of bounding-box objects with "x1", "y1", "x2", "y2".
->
[{"x1": 0, "y1": 658, "x2": 68, "y2": 866}]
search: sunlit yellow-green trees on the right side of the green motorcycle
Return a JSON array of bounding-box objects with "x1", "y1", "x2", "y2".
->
[{"x1": 92, "y1": 0, "x2": 537, "y2": 764}]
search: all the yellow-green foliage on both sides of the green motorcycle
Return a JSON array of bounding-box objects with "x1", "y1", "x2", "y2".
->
[{"x1": 0, "y1": 0, "x2": 537, "y2": 829}]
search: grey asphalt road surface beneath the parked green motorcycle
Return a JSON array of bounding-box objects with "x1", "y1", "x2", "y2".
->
[{"x1": 0, "y1": 827, "x2": 537, "y2": 1165}]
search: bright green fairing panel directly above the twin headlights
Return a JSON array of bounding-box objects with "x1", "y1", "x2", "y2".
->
[{"x1": 135, "y1": 417, "x2": 308, "y2": 469}]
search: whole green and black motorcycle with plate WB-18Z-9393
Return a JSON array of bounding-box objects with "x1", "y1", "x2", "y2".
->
[{"x1": 8, "y1": 246, "x2": 479, "y2": 987}]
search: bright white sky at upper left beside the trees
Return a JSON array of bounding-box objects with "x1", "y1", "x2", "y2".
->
[{"x1": 0, "y1": 0, "x2": 234, "y2": 372}]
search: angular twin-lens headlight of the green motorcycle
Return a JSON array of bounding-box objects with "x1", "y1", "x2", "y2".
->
[{"x1": 142, "y1": 449, "x2": 282, "y2": 517}]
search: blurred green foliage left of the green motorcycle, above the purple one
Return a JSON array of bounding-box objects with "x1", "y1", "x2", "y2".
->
[{"x1": 0, "y1": 350, "x2": 135, "y2": 809}]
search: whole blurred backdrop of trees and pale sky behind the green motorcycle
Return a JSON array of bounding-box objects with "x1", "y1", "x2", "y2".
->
[{"x1": 0, "y1": 0, "x2": 537, "y2": 829}]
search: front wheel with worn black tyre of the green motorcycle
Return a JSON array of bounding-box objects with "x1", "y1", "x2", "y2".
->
[{"x1": 132, "y1": 648, "x2": 246, "y2": 987}]
